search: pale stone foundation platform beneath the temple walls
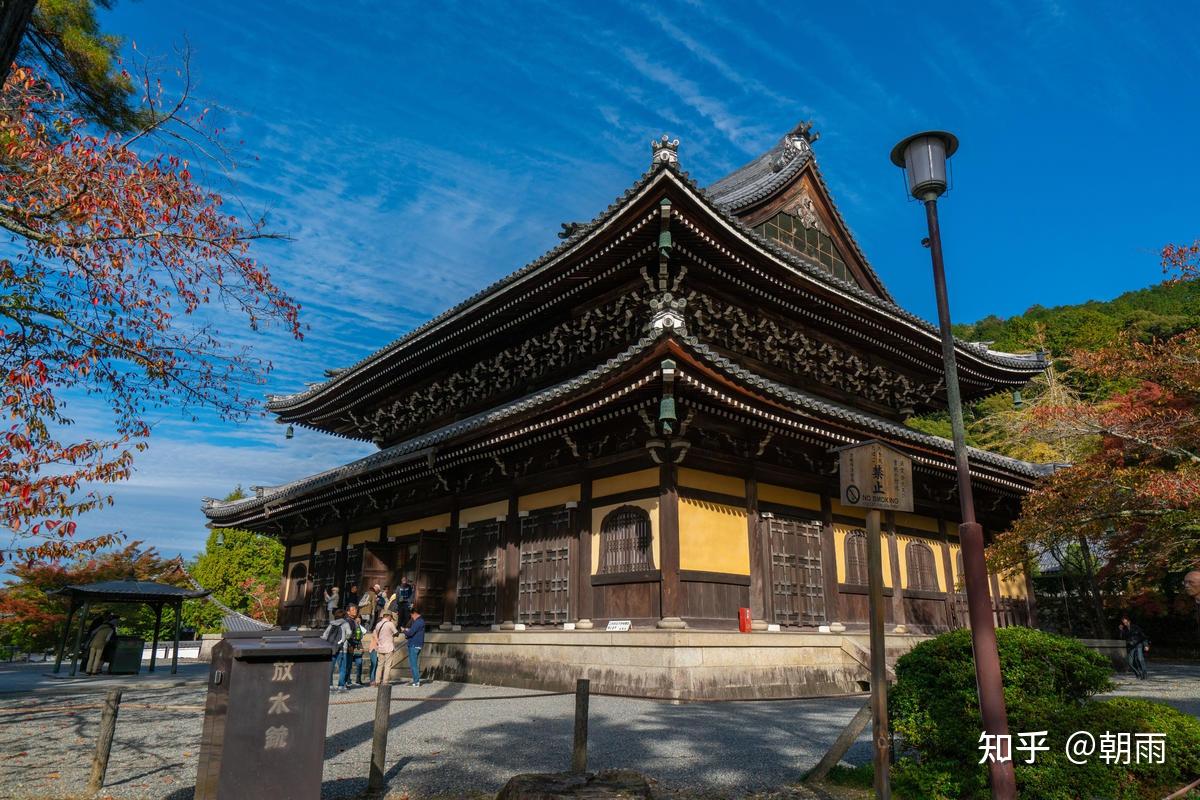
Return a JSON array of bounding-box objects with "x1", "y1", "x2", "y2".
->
[{"x1": 422, "y1": 630, "x2": 929, "y2": 700}]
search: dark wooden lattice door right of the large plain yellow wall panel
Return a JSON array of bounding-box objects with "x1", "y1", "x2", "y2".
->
[{"x1": 763, "y1": 516, "x2": 826, "y2": 625}]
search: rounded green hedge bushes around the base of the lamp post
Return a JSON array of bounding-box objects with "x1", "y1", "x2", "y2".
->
[{"x1": 889, "y1": 627, "x2": 1200, "y2": 800}]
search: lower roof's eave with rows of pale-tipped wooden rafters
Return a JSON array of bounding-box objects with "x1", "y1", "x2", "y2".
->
[{"x1": 211, "y1": 333, "x2": 1046, "y2": 537}]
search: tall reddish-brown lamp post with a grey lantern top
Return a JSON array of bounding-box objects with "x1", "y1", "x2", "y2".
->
[{"x1": 892, "y1": 131, "x2": 1016, "y2": 800}]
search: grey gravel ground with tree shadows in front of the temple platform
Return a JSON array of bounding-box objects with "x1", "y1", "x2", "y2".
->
[{"x1": 0, "y1": 664, "x2": 1200, "y2": 800}]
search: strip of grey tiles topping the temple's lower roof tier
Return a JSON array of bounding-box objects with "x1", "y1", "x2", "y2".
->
[{"x1": 203, "y1": 332, "x2": 1054, "y2": 521}]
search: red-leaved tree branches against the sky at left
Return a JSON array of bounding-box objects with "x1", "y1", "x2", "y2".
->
[{"x1": 0, "y1": 67, "x2": 301, "y2": 560}]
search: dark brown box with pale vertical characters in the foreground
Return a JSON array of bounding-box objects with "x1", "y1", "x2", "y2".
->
[{"x1": 194, "y1": 631, "x2": 334, "y2": 800}]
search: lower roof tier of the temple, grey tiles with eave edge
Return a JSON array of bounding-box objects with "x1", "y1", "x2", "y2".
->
[{"x1": 211, "y1": 331, "x2": 1054, "y2": 527}]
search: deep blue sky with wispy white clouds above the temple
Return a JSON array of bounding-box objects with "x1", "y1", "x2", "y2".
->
[{"x1": 39, "y1": 0, "x2": 1200, "y2": 563}]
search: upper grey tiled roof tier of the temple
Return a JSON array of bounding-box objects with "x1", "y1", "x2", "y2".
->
[{"x1": 268, "y1": 137, "x2": 1045, "y2": 438}]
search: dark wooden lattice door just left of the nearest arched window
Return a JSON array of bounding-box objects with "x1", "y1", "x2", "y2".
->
[{"x1": 517, "y1": 509, "x2": 571, "y2": 625}]
